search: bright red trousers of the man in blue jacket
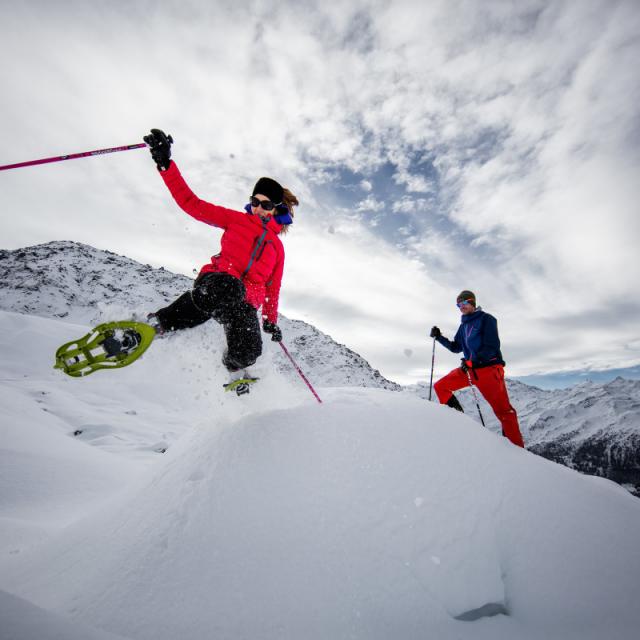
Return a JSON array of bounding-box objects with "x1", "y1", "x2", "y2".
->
[{"x1": 433, "y1": 364, "x2": 524, "y2": 447}]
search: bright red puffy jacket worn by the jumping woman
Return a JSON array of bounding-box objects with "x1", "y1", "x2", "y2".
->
[{"x1": 160, "y1": 162, "x2": 284, "y2": 323}]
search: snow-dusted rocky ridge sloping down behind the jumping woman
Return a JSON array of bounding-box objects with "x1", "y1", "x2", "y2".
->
[{"x1": 0, "y1": 241, "x2": 402, "y2": 391}]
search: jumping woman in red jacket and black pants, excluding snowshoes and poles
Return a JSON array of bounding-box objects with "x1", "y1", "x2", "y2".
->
[{"x1": 144, "y1": 129, "x2": 298, "y2": 382}]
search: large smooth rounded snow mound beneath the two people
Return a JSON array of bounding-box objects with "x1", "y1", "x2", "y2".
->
[{"x1": 3, "y1": 389, "x2": 640, "y2": 639}]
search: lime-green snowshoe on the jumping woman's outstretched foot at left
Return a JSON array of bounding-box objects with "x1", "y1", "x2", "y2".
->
[{"x1": 53, "y1": 320, "x2": 156, "y2": 378}]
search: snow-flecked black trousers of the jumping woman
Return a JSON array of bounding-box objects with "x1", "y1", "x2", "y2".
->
[{"x1": 155, "y1": 273, "x2": 262, "y2": 371}]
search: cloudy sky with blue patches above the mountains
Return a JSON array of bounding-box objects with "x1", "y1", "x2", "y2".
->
[{"x1": 0, "y1": 0, "x2": 640, "y2": 384}]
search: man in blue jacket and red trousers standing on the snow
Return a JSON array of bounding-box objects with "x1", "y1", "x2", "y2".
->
[{"x1": 431, "y1": 291, "x2": 524, "y2": 447}]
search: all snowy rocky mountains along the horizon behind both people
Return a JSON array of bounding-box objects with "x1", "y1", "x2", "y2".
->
[{"x1": 0, "y1": 241, "x2": 640, "y2": 496}]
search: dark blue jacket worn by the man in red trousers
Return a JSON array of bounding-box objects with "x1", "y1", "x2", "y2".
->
[{"x1": 436, "y1": 307, "x2": 504, "y2": 369}]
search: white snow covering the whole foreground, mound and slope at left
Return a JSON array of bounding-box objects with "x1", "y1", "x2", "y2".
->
[{"x1": 0, "y1": 311, "x2": 640, "y2": 640}]
